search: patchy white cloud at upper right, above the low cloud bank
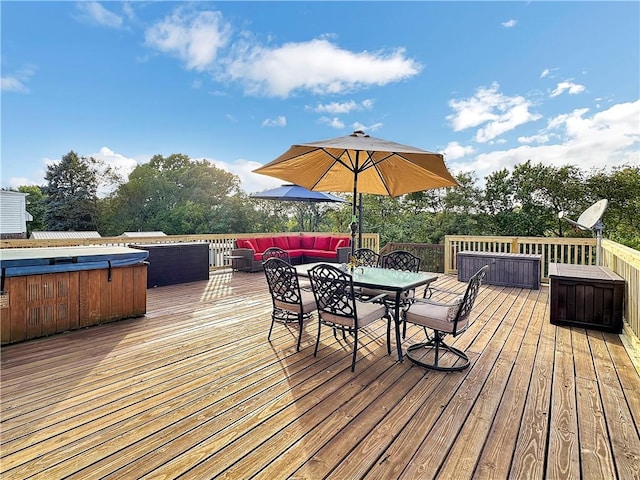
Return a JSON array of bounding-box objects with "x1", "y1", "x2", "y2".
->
[{"x1": 447, "y1": 83, "x2": 541, "y2": 143}]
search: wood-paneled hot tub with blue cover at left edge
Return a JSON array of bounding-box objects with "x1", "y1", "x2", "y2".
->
[{"x1": 0, "y1": 247, "x2": 148, "y2": 345}]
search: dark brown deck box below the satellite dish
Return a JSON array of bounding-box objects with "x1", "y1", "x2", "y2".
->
[{"x1": 549, "y1": 263, "x2": 625, "y2": 333}]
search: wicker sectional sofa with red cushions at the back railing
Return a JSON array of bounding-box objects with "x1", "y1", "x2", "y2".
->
[{"x1": 231, "y1": 235, "x2": 351, "y2": 272}]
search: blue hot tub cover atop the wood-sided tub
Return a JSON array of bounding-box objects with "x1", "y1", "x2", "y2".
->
[{"x1": 0, "y1": 246, "x2": 149, "y2": 277}]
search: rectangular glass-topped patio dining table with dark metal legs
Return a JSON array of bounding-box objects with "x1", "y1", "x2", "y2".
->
[{"x1": 295, "y1": 262, "x2": 438, "y2": 362}]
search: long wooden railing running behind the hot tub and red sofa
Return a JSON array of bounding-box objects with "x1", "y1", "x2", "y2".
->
[{"x1": 0, "y1": 232, "x2": 380, "y2": 270}]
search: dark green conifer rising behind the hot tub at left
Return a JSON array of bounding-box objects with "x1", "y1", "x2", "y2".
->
[{"x1": 43, "y1": 151, "x2": 100, "y2": 231}]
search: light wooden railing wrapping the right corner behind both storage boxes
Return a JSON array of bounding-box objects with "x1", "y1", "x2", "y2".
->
[{"x1": 444, "y1": 235, "x2": 640, "y2": 351}]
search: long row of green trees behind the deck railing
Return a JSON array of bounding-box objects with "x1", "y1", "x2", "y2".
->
[{"x1": 6, "y1": 151, "x2": 640, "y2": 250}]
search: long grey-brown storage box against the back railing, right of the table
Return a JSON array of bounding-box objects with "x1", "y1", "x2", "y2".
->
[{"x1": 457, "y1": 251, "x2": 541, "y2": 290}]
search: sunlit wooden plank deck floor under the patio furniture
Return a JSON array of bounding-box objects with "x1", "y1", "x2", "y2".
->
[{"x1": 0, "y1": 271, "x2": 640, "y2": 480}]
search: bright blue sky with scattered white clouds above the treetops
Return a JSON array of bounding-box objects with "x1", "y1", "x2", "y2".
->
[{"x1": 0, "y1": 1, "x2": 640, "y2": 193}]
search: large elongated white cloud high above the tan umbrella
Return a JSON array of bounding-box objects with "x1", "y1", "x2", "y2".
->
[{"x1": 220, "y1": 39, "x2": 421, "y2": 98}]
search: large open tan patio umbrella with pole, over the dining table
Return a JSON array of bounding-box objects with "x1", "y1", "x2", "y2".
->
[{"x1": 254, "y1": 130, "x2": 458, "y2": 251}]
